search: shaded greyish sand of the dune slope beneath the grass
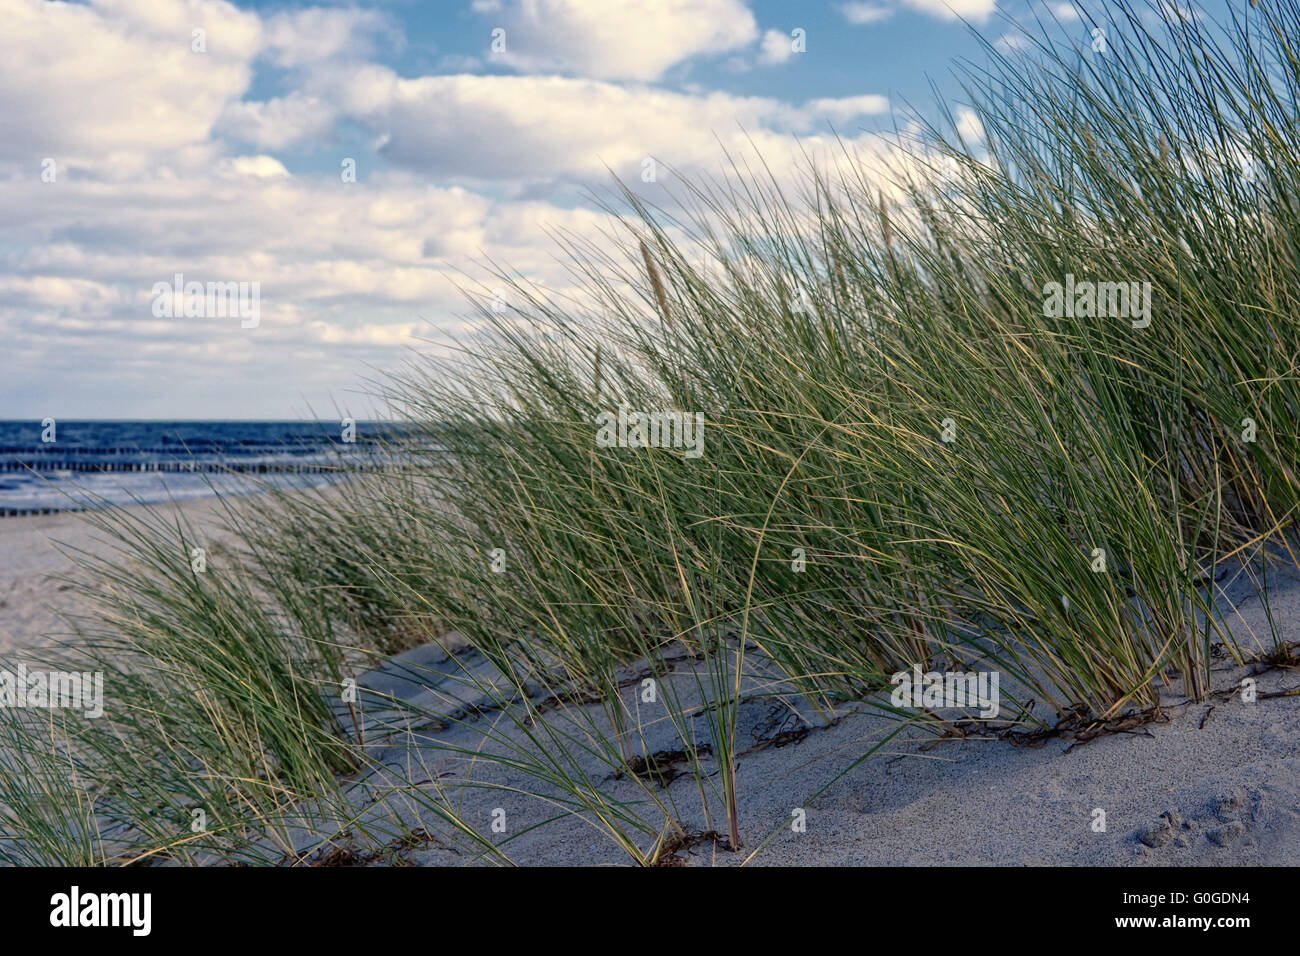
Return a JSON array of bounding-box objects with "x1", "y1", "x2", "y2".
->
[{"x1": 327, "y1": 579, "x2": 1300, "y2": 866}]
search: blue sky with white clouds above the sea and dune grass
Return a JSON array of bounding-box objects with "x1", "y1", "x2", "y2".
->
[{"x1": 0, "y1": 0, "x2": 1102, "y2": 419}]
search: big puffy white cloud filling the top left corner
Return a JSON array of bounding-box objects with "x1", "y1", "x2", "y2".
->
[{"x1": 0, "y1": 0, "x2": 387, "y2": 171}]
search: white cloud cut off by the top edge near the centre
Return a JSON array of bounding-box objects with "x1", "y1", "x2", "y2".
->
[{"x1": 473, "y1": 0, "x2": 758, "y2": 81}]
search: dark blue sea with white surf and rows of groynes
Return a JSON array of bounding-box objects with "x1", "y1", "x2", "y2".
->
[{"x1": 0, "y1": 420, "x2": 398, "y2": 516}]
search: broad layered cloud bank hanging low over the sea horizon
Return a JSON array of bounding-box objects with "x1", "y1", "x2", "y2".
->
[{"x1": 0, "y1": 156, "x2": 629, "y2": 418}]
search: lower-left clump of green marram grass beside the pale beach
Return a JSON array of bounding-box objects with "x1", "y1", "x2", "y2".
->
[{"x1": 0, "y1": 509, "x2": 504, "y2": 865}]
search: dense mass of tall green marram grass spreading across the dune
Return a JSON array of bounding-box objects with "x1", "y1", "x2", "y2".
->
[{"x1": 0, "y1": 0, "x2": 1300, "y2": 864}]
